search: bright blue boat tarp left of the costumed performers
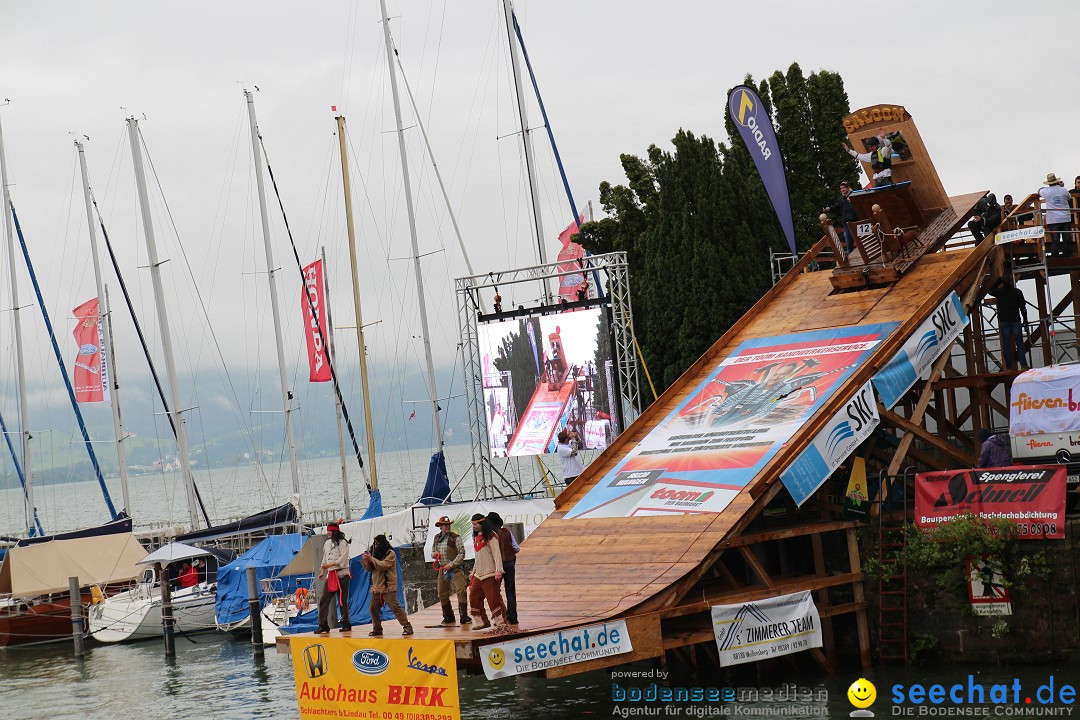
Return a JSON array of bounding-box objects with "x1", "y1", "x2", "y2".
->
[{"x1": 214, "y1": 533, "x2": 305, "y2": 625}]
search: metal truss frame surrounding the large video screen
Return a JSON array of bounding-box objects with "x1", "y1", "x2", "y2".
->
[{"x1": 455, "y1": 253, "x2": 640, "y2": 500}]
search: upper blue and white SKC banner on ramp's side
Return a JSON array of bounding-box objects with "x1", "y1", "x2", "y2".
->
[{"x1": 874, "y1": 293, "x2": 968, "y2": 410}]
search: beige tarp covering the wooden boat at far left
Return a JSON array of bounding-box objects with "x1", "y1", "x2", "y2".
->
[{"x1": 0, "y1": 532, "x2": 146, "y2": 597}]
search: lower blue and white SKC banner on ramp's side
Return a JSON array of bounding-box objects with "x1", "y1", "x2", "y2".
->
[{"x1": 780, "y1": 381, "x2": 881, "y2": 507}]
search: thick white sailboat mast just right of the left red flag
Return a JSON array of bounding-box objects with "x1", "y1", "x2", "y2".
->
[{"x1": 127, "y1": 118, "x2": 199, "y2": 530}]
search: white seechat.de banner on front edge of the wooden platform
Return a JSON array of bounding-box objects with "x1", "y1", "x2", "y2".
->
[{"x1": 480, "y1": 620, "x2": 634, "y2": 680}]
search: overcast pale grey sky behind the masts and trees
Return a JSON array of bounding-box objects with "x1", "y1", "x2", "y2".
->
[{"x1": 0, "y1": 0, "x2": 1080, "y2": 431}]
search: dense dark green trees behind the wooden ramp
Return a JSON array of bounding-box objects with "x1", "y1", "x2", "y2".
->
[{"x1": 579, "y1": 64, "x2": 858, "y2": 397}]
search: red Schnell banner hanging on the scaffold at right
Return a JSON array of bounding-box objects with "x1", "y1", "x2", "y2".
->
[{"x1": 915, "y1": 465, "x2": 1067, "y2": 540}]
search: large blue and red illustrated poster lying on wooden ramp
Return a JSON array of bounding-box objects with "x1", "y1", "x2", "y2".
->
[{"x1": 566, "y1": 323, "x2": 899, "y2": 518}]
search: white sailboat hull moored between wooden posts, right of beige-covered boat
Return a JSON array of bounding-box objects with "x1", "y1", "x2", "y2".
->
[{"x1": 90, "y1": 583, "x2": 217, "y2": 642}]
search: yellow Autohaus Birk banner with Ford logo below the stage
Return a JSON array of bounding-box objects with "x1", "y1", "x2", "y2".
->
[{"x1": 289, "y1": 637, "x2": 461, "y2": 720}]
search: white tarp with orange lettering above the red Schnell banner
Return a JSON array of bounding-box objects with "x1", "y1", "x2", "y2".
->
[{"x1": 1009, "y1": 365, "x2": 1080, "y2": 437}]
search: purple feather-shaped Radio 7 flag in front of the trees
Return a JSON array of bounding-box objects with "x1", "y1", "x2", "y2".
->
[{"x1": 728, "y1": 85, "x2": 798, "y2": 255}]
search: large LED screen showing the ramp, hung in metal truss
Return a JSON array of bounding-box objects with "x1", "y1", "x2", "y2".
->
[{"x1": 478, "y1": 307, "x2": 619, "y2": 458}]
